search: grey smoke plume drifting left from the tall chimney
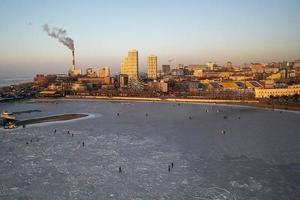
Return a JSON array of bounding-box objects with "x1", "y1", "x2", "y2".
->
[{"x1": 43, "y1": 24, "x2": 74, "y2": 51}]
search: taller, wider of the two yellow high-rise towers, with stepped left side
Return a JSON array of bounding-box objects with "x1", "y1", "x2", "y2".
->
[{"x1": 121, "y1": 49, "x2": 139, "y2": 80}]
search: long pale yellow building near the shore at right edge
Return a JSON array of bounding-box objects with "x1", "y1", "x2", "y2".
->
[{"x1": 255, "y1": 85, "x2": 300, "y2": 98}]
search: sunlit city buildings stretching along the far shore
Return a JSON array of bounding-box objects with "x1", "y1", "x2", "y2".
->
[{"x1": 35, "y1": 49, "x2": 300, "y2": 98}]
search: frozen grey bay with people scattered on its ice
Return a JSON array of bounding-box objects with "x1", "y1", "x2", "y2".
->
[{"x1": 0, "y1": 99, "x2": 300, "y2": 200}]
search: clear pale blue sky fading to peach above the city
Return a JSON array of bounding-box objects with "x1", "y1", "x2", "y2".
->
[{"x1": 0, "y1": 0, "x2": 300, "y2": 77}]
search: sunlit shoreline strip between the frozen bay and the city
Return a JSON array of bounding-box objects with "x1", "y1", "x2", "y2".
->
[{"x1": 63, "y1": 95, "x2": 300, "y2": 111}]
